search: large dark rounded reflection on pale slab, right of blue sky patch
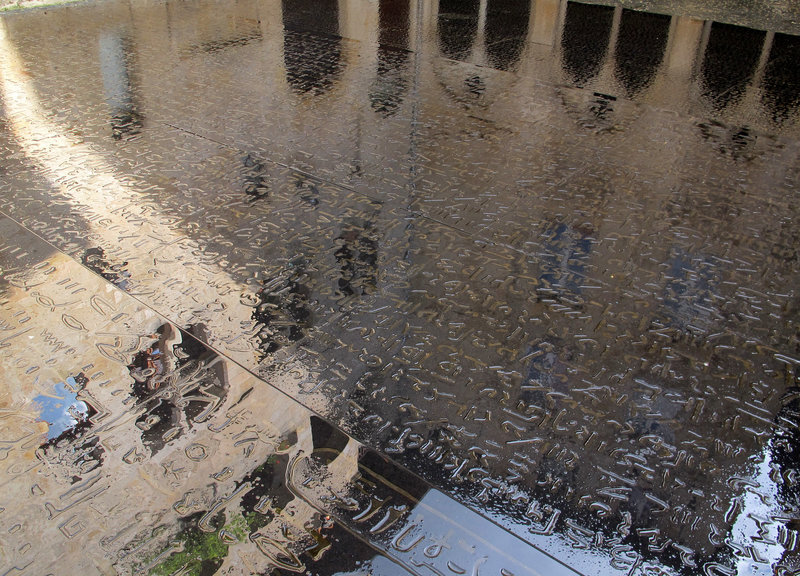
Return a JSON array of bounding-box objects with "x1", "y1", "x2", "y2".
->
[{"x1": 128, "y1": 324, "x2": 228, "y2": 455}]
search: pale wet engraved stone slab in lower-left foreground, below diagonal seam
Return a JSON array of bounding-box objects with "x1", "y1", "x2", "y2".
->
[{"x1": 0, "y1": 218, "x2": 576, "y2": 575}]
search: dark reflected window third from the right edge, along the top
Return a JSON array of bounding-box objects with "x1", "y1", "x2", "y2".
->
[{"x1": 614, "y1": 10, "x2": 670, "y2": 98}]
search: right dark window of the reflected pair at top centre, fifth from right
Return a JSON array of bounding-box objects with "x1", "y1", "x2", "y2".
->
[{"x1": 486, "y1": 0, "x2": 531, "y2": 70}]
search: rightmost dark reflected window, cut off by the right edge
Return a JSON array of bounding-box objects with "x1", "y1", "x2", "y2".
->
[{"x1": 762, "y1": 34, "x2": 800, "y2": 122}]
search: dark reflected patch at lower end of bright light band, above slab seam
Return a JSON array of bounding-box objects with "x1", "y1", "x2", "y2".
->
[{"x1": 252, "y1": 258, "x2": 311, "y2": 358}]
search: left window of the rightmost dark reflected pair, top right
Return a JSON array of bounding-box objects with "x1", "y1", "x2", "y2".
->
[{"x1": 703, "y1": 22, "x2": 766, "y2": 110}]
